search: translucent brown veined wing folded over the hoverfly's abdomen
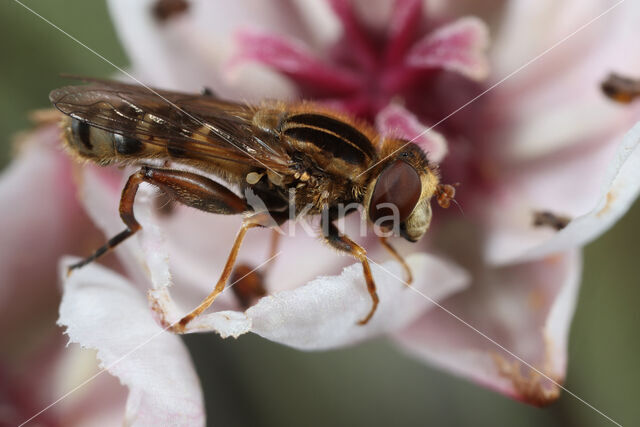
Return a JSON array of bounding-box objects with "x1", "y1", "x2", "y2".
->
[{"x1": 49, "y1": 79, "x2": 291, "y2": 173}]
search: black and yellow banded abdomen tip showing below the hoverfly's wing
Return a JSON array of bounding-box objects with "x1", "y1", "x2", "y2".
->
[{"x1": 63, "y1": 117, "x2": 162, "y2": 165}]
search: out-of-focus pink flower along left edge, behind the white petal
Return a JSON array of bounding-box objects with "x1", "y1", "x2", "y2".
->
[{"x1": 0, "y1": 125, "x2": 126, "y2": 425}]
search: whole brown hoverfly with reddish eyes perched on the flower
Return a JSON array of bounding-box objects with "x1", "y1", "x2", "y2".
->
[{"x1": 50, "y1": 79, "x2": 455, "y2": 333}]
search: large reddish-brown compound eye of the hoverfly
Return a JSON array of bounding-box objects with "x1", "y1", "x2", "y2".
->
[{"x1": 369, "y1": 160, "x2": 422, "y2": 227}]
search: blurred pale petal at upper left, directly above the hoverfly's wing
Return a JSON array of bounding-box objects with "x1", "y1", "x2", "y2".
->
[{"x1": 109, "y1": 0, "x2": 330, "y2": 100}]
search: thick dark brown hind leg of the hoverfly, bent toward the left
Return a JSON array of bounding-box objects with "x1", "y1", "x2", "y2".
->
[{"x1": 68, "y1": 166, "x2": 249, "y2": 273}]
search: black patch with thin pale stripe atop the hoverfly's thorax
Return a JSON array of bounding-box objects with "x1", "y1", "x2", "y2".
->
[{"x1": 281, "y1": 113, "x2": 376, "y2": 166}]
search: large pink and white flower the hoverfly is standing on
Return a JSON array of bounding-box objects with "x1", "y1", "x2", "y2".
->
[{"x1": 3, "y1": 0, "x2": 640, "y2": 424}]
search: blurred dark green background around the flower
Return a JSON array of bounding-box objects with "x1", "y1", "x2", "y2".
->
[{"x1": 0, "y1": 0, "x2": 640, "y2": 426}]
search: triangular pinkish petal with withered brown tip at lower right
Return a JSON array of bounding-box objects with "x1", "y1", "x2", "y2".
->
[{"x1": 396, "y1": 251, "x2": 582, "y2": 406}]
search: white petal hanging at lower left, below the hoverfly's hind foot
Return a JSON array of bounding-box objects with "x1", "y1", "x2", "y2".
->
[{"x1": 58, "y1": 260, "x2": 205, "y2": 425}]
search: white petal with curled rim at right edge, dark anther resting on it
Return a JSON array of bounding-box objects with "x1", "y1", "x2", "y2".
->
[{"x1": 486, "y1": 123, "x2": 640, "y2": 264}]
